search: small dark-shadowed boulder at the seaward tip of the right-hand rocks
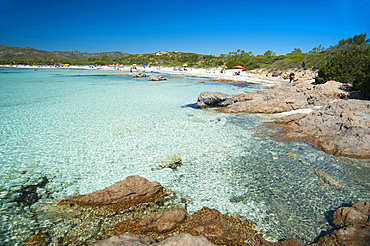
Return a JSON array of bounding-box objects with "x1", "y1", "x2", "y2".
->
[{"x1": 196, "y1": 91, "x2": 235, "y2": 108}]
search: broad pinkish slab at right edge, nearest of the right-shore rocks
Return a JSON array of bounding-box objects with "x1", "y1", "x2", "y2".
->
[{"x1": 275, "y1": 99, "x2": 370, "y2": 159}]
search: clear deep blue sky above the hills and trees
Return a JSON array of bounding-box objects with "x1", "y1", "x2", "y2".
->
[{"x1": 0, "y1": 0, "x2": 370, "y2": 55}]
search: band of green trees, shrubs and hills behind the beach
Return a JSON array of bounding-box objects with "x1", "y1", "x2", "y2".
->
[{"x1": 0, "y1": 33, "x2": 370, "y2": 92}]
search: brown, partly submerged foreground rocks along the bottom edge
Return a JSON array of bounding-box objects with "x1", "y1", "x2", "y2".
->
[{"x1": 23, "y1": 176, "x2": 370, "y2": 246}]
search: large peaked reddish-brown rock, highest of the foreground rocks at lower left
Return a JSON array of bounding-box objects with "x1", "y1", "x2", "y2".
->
[{"x1": 59, "y1": 175, "x2": 164, "y2": 211}]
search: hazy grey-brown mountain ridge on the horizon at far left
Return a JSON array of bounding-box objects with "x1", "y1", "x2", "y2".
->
[{"x1": 0, "y1": 44, "x2": 129, "y2": 60}]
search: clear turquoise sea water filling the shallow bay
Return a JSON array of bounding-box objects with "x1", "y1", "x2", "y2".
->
[{"x1": 0, "y1": 68, "x2": 370, "y2": 245}]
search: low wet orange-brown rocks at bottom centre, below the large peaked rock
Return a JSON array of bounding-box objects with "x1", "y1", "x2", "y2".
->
[{"x1": 107, "y1": 208, "x2": 304, "y2": 246}]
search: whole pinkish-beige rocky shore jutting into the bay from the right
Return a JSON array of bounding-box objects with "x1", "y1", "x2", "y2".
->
[{"x1": 196, "y1": 80, "x2": 370, "y2": 159}]
